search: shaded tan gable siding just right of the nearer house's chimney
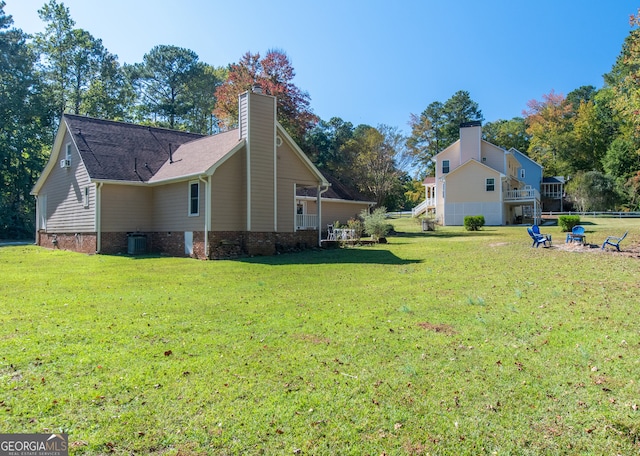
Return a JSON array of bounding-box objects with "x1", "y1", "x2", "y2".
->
[{"x1": 276, "y1": 142, "x2": 318, "y2": 232}]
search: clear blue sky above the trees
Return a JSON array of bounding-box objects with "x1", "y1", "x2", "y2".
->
[{"x1": 4, "y1": 0, "x2": 640, "y2": 132}]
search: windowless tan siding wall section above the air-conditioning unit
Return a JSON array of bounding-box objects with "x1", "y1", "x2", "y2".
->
[{"x1": 100, "y1": 184, "x2": 153, "y2": 233}]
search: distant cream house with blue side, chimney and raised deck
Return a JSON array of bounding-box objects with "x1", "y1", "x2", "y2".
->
[{"x1": 414, "y1": 122, "x2": 542, "y2": 225}]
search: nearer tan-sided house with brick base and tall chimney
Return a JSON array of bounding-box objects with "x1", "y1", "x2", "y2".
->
[{"x1": 31, "y1": 92, "x2": 370, "y2": 258}]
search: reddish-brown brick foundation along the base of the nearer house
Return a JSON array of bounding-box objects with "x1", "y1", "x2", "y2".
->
[{"x1": 38, "y1": 230, "x2": 318, "y2": 260}]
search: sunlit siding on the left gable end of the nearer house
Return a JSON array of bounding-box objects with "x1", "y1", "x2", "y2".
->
[{"x1": 39, "y1": 134, "x2": 96, "y2": 233}]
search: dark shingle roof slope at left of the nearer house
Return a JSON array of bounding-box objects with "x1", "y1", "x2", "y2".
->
[{"x1": 64, "y1": 114, "x2": 204, "y2": 182}]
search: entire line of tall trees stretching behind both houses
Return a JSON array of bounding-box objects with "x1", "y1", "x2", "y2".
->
[{"x1": 0, "y1": 0, "x2": 640, "y2": 239}]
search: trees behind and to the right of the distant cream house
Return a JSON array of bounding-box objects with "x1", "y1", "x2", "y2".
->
[{"x1": 407, "y1": 9, "x2": 640, "y2": 211}]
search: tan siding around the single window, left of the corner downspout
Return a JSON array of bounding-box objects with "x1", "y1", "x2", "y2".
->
[{"x1": 153, "y1": 180, "x2": 206, "y2": 231}]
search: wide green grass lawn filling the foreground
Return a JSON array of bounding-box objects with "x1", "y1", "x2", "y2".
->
[{"x1": 0, "y1": 218, "x2": 640, "y2": 455}]
